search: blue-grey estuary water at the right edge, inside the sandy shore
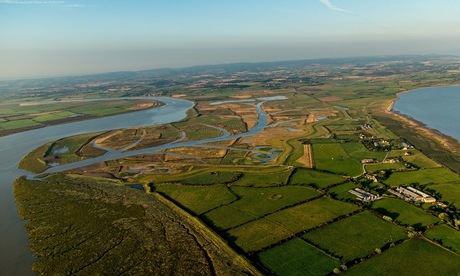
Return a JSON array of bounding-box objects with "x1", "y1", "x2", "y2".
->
[{"x1": 393, "y1": 86, "x2": 460, "y2": 141}]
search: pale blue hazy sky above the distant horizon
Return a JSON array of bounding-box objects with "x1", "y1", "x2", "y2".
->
[{"x1": 0, "y1": 0, "x2": 460, "y2": 80}]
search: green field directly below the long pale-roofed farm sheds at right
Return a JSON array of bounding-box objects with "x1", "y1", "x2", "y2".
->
[{"x1": 371, "y1": 198, "x2": 439, "y2": 229}]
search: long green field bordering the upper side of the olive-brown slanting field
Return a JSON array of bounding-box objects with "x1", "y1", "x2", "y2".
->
[{"x1": 204, "y1": 186, "x2": 319, "y2": 229}]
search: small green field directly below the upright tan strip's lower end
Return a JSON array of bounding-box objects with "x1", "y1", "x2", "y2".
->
[{"x1": 289, "y1": 168, "x2": 345, "y2": 188}]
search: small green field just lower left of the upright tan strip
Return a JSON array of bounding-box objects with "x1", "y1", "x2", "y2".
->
[{"x1": 232, "y1": 168, "x2": 292, "y2": 187}]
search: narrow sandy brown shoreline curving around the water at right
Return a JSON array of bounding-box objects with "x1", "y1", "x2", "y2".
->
[{"x1": 385, "y1": 88, "x2": 460, "y2": 153}]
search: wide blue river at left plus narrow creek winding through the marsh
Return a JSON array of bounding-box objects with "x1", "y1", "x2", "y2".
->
[{"x1": 0, "y1": 97, "x2": 279, "y2": 275}]
